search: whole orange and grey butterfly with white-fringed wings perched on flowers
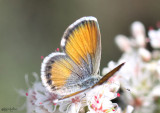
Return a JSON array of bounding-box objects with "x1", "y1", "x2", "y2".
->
[{"x1": 41, "y1": 16, "x2": 124, "y2": 100}]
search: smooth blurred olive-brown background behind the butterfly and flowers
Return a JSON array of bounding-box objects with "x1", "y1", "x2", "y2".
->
[{"x1": 0, "y1": 0, "x2": 160, "y2": 113}]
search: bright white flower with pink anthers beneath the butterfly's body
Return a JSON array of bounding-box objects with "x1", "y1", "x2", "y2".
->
[{"x1": 86, "y1": 83, "x2": 119, "y2": 113}]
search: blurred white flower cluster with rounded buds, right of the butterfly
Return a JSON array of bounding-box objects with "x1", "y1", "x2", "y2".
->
[{"x1": 102, "y1": 21, "x2": 160, "y2": 113}]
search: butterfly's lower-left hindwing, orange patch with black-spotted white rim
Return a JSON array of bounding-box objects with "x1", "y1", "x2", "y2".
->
[{"x1": 41, "y1": 52, "x2": 83, "y2": 95}]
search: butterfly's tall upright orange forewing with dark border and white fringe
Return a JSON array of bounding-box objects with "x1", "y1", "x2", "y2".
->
[{"x1": 61, "y1": 17, "x2": 101, "y2": 76}]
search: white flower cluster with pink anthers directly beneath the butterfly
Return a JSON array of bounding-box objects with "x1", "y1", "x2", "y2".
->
[{"x1": 19, "y1": 73, "x2": 133, "y2": 113}]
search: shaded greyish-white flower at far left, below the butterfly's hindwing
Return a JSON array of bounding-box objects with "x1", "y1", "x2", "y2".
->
[{"x1": 26, "y1": 74, "x2": 57, "y2": 113}]
